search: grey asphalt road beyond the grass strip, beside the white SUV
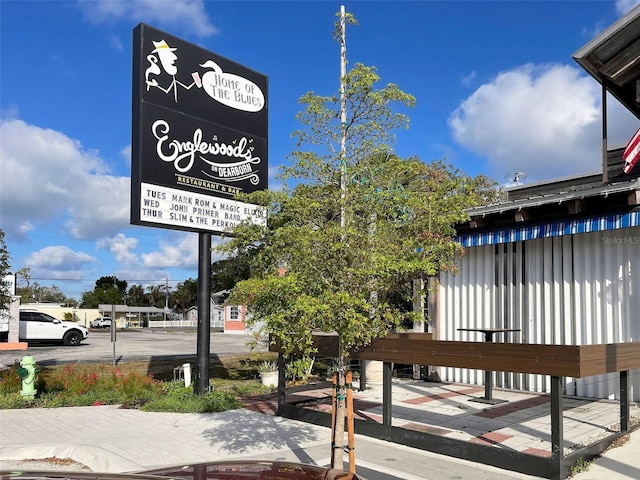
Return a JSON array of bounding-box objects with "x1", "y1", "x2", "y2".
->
[{"x1": 0, "y1": 329, "x2": 266, "y2": 365}]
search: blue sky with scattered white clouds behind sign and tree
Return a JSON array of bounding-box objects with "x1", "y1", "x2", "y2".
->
[{"x1": 0, "y1": 0, "x2": 639, "y2": 299}]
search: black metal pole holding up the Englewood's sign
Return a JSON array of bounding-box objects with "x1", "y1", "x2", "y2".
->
[{"x1": 195, "y1": 232, "x2": 211, "y2": 395}]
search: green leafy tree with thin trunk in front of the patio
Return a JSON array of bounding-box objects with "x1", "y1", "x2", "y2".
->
[{"x1": 219, "y1": 9, "x2": 494, "y2": 466}]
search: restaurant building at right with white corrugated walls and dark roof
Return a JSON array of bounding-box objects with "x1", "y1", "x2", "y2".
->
[{"x1": 430, "y1": 6, "x2": 640, "y2": 401}]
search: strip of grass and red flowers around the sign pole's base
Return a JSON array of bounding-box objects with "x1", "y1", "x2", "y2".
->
[{"x1": 0, "y1": 353, "x2": 274, "y2": 413}]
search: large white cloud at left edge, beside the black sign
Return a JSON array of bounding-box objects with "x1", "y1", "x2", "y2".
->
[{"x1": 0, "y1": 120, "x2": 130, "y2": 240}]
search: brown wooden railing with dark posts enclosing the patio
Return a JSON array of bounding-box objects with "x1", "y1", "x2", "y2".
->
[{"x1": 269, "y1": 333, "x2": 640, "y2": 480}]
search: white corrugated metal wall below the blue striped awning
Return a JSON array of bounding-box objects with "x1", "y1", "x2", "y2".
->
[{"x1": 437, "y1": 227, "x2": 640, "y2": 401}]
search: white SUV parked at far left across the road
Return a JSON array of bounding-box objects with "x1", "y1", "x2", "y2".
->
[{"x1": 19, "y1": 310, "x2": 89, "y2": 346}]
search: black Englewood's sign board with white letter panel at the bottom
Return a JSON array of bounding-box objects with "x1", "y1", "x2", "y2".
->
[{"x1": 131, "y1": 24, "x2": 268, "y2": 232}]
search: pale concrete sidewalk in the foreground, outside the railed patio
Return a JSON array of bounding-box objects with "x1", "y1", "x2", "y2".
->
[{"x1": 0, "y1": 406, "x2": 535, "y2": 480}]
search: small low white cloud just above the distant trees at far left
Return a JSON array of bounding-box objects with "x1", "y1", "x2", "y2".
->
[{"x1": 24, "y1": 245, "x2": 96, "y2": 279}]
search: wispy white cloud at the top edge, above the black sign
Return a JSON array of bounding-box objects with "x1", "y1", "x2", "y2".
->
[{"x1": 77, "y1": 0, "x2": 218, "y2": 37}]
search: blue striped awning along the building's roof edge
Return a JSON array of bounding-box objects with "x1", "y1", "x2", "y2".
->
[{"x1": 455, "y1": 212, "x2": 640, "y2": 247}]
